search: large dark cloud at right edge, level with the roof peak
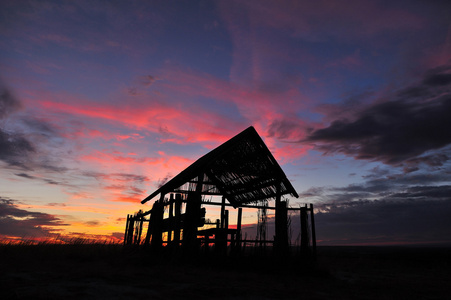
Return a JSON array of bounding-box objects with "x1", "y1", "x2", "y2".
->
[{"x1": 303, "y1": 66, "x2": 451, "y2": 171}]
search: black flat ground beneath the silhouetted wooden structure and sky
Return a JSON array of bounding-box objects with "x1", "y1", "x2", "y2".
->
[{"x1": 0, "y1": 245, "x2": 451, "y2": 299}]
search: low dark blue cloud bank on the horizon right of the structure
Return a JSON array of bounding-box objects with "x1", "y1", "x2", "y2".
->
[{"x1": 315, "y1": 195, "x2": 451, "y2": 245}]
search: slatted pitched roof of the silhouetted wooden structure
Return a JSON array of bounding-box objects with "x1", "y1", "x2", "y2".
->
[{"x1": 141, "y1": 126, "x2": 299, "y2": 207}]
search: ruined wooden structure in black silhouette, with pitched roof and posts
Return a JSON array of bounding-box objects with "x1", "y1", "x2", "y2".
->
[{"x1": 124, "y1": 127, "x2": 316, "y2": 256}]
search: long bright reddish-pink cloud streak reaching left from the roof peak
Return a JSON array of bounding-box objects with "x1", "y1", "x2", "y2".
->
[{"x1": 33, "y1": 86, "x2": 244, "y2": 148}]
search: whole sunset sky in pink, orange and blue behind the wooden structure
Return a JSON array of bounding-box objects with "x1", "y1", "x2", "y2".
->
[{"x1": 0, "y1": 0, "x2": 451, "y2": 245}]
